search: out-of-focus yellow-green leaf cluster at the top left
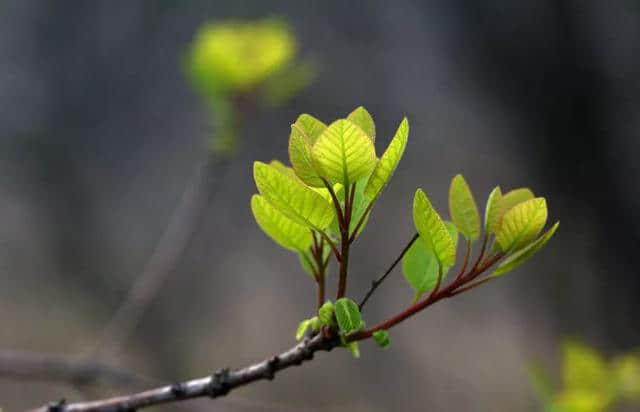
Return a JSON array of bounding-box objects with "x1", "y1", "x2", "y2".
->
[{"x1": 186, "y1": 18, "x2": 314, "y2": 155}]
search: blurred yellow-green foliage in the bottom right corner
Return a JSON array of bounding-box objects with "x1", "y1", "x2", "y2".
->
[{"x1": 529, "y1": 341, "x2": 640, "y2": 412}]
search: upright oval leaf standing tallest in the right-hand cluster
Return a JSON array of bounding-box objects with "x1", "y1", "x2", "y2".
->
[{"x1": 449, "y1": 175, "x2": 480, "y2": 241}]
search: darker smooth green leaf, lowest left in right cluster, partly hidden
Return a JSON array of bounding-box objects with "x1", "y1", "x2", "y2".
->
[{"x1": 402, "y1": 222, "x2": 458, "y2": 301}]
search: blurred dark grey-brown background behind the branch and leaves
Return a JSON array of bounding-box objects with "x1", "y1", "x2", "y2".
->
[{"x1": 0, "y1": 0, "x2": 640, "y2": 412}]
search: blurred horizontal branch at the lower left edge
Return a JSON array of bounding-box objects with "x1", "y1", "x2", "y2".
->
[{"x1": 0, "y1": 351, "x2": 153, "y2": 387}]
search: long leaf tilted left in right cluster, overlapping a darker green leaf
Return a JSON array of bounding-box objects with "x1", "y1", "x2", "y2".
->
[{"x1": 413, "y1": 189, "x2": 456, "y2": 267}]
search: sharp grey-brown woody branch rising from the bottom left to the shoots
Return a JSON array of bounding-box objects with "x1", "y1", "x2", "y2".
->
[{"x1": 32, "y1": 333, "x2": 339, "y2": 412}]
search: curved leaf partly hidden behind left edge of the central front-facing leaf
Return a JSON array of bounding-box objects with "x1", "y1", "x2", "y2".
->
[{"x1": 289, "y1": 114, "x2": 327, "y2": 187}]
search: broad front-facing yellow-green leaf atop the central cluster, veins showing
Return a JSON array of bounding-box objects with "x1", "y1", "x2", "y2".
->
[{"x1": 311, "y1": 119, "x2": 377, "y2": 188}]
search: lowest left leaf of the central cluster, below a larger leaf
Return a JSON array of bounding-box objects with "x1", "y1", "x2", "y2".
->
[{"x1": 251, "y1": 195, "x2": 312, "y2": 252}]
